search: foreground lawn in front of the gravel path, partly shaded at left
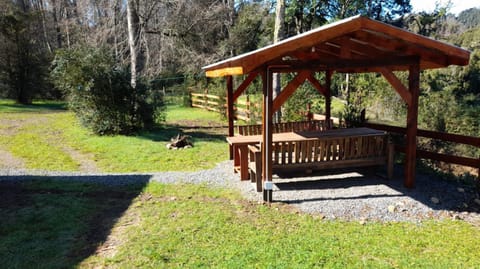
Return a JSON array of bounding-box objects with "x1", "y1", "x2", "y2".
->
[{"x1": 0, "y1": 176, "x2": 480, "y2": 268}]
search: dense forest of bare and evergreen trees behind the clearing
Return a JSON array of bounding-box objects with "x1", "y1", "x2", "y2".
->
[{"x1": 0, "y1": 0, "x2": 480, "y2": 165}]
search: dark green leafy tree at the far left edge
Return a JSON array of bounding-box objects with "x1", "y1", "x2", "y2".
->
[{"x1": 0, "y1": 0, "x2": 50, "y2": 104}]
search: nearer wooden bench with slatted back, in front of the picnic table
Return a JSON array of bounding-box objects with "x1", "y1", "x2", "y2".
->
[{"x1": 248, "y1": 131, "x2": 393, "y2": 192}]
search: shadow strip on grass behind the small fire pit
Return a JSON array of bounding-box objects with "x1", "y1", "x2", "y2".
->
[{"x1": 138, "y1": 125, "x2": 226, "y2": 143}]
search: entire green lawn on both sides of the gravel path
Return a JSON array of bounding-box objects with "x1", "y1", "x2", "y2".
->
[{"x1": 0, "y1": 101, "x2": 480, "y2": 268}]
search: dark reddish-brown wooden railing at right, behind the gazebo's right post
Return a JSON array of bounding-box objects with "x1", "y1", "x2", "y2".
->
[{"x1": 364, "y1": 123, "x2": 480, "y2": 177}]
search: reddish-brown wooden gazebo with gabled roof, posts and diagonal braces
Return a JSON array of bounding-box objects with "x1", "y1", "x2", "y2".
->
[{"x1": 203, "y1": 16, "x2": 470, "y2": 197}]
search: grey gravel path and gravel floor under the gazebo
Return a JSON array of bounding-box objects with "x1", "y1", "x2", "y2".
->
[{"x1": 0, "y1": 161, "x2": 480, "y2": 222}]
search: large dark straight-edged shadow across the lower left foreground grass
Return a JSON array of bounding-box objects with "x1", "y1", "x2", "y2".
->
[{"x1": 0, "y1": 175, "x2": 151, "y2": 268}]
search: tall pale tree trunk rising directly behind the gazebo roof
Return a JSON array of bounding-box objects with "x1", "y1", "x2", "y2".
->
[{"x1": 272, "y1": 0, "x2": 285, "y2": 122}]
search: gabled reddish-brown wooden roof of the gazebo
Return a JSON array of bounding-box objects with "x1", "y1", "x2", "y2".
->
[{"x1": 203, "y1": 16, "x2": 470, "y2": 77}]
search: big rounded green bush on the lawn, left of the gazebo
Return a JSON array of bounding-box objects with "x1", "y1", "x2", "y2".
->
[{"x1": 51, "y1": 47, "x2": 164, "y2": 135}]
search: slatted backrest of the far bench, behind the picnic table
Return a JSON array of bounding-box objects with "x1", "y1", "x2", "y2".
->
[{"x1": 237, "y1": 120, "x2": 333, "y2": 135}]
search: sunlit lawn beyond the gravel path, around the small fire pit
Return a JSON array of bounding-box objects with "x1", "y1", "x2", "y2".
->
[{"x1": 0, "y1": 101, "x2": 228, "y2": 172}]
